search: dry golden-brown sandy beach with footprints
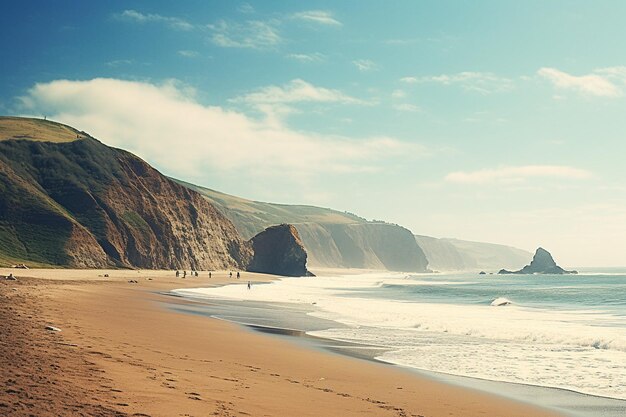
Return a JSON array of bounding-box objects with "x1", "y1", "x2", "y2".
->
[{"x1": 0, "y1": 269, "x2": 556, "y2": 417}]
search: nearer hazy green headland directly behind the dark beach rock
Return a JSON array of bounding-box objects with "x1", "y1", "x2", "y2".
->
[{"x1": 179, "y1": 181, "x2": 428, "y2": 272}]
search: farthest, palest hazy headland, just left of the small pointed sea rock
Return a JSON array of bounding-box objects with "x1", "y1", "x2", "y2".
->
[{"x1": 415, "y1": 235, "x2": 531, "y2": 271}]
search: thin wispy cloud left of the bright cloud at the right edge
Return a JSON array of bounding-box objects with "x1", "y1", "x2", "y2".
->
[{"x1": 400, "y1": 71, "x2": 515, "y2": 94}]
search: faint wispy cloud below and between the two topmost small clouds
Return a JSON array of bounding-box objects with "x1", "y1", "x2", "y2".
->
[{"x1": 207, "y1": 20, "x2": 283, "y2": 49}]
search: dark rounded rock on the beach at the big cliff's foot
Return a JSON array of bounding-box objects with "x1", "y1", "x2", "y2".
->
[{"x1": 248, "y1": 224, "x2": 313, "y2": 277}]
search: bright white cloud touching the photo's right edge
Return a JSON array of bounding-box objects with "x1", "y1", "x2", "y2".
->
[{"x1": 537, "y1": 67, "x2": 626, "y2": 97}]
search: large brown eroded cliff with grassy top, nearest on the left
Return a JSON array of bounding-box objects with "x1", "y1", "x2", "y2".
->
[{"x1": 0, "y1": 117, "x2": 252, "y2": 269}]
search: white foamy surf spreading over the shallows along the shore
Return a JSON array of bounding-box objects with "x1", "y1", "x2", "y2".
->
[{"x1": 176, "y1": 274, "x2": 626, "y2": 399}]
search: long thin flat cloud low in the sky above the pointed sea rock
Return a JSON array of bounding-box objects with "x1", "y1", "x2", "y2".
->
[{"x1": 445, "y1": 165, "x2": 592, "y2": 184}]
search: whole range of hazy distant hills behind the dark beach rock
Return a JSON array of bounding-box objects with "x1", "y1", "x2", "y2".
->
[{"x1": 182, "y1": 180, "x2": 531, "y2": 271}]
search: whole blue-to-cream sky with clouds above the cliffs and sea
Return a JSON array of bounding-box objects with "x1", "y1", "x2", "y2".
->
[{"x1": 0, "y1": 0, "x2": 626, "y2": 266}]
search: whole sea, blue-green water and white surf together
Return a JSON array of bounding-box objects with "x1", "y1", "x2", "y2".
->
[{"x1": 173, "y1": 270, "x2": 626, "y2": 399}]
